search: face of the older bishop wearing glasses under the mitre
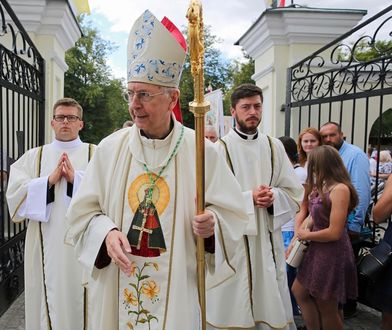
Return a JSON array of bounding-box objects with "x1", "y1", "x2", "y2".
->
[{"x1": 128, "y1": 82, "x2": 179, "y2": 139}]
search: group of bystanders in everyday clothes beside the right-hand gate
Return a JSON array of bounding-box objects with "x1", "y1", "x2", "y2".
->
[{"x1": 280, "y1": 122, "x2": 391, "y2": 329}]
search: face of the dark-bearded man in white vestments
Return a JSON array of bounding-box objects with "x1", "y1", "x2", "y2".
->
[{"x1": 231, "y1": 95, "x2": 263, "y2": 134}]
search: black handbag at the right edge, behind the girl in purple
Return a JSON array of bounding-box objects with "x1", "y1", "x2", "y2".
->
[{"x1": 357, "y1": 240, "x2": 392, "y2": 280}]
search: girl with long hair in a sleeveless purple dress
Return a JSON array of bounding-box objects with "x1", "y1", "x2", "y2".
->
[{"x1": 292, "y1": 145, "x2": 358, "y2": 330}]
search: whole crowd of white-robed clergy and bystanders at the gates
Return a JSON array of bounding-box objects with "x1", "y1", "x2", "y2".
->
[{"x1": 3, "y1": 10, "x2": 392, "y2": 330}]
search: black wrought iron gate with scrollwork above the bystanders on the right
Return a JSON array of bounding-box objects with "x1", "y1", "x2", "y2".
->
[{"x1": 285, "y1": 6, "x2": 392, "y2": 202}]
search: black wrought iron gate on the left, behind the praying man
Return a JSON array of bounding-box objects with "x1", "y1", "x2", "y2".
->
[{"x1": 0, "y1": 0, "x2": 45, "y2": 315}]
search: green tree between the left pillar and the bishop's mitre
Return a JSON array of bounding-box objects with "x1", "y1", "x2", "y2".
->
[{"x1": 64, "y1": 17, "x2": 129, "y2": 143}]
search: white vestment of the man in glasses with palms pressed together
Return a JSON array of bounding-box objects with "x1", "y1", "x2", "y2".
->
[{"x1": 7, "y1": 138, "x2": 90, "y2": 330}]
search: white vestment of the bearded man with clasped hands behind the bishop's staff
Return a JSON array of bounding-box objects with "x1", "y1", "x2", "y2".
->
[{"x1": 207, "y1": 130, "x2": 303, "y2": 329}]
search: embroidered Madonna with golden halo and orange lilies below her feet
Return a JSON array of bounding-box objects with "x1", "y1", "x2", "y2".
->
[{"x1": 122, "y1": 173, "x2": 170, "y2": 329}]
